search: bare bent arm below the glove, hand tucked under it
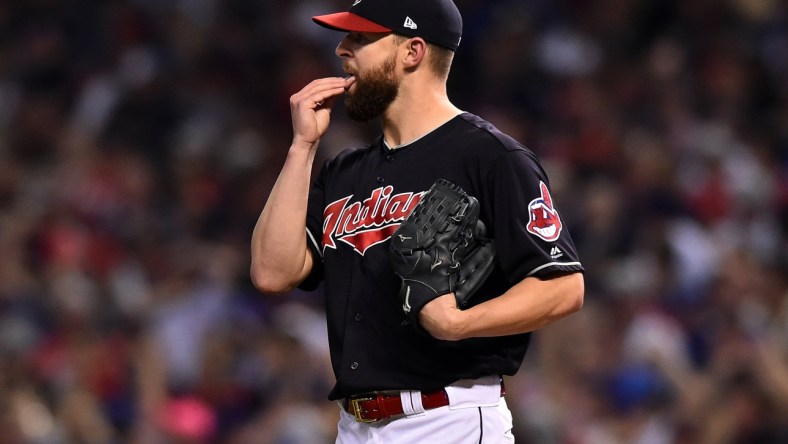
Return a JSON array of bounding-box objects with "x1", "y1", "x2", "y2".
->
[{"x1": 419, "y1": 273, "x2": 585, "y2": 341}]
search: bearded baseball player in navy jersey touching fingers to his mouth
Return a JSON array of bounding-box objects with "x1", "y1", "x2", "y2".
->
[{"x1": 251, "y1": 0, "x2": 584, "y2": 443}]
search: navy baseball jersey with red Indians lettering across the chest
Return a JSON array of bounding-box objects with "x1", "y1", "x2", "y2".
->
[{"x1": 301, "y1": 113, "x2": 583, "y2": 399}]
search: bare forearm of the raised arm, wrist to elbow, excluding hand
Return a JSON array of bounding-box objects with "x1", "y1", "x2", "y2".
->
[{"x1": 251, "y1": 145, "x2": 315, "y2": 293}]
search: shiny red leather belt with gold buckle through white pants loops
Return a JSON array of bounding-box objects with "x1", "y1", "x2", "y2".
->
[{"x1": 343, "y1": 390, "x2": 449, "y2": 422}]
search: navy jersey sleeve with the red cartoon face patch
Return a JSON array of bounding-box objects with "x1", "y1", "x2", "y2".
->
[{"x1": 487, "y1": 149, "x2": 583, "y2": 282}]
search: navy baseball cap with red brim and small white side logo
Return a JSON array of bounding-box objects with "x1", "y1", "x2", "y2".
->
[{"x1": 312, "y1": 0, "x2": 462, "y2": 51}]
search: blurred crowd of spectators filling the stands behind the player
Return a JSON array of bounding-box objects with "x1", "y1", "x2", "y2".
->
[{"x1": 0, "y1": 0, "x2": 788, "y2": 444}]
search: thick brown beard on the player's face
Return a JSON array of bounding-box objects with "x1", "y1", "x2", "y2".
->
[{"x1": 345, "y1": 55, "x2": 399, "y2": 122}]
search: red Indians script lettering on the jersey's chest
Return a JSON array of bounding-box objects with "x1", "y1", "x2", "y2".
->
[{"x1": 323, "y1": 186, "x2": 424, "y2": 256}]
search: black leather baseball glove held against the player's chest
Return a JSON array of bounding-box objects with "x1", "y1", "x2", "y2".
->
[{"x1": 389, "y1": 179, "x2": 495, "y2": 329}]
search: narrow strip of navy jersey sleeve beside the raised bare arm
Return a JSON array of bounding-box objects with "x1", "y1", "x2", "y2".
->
[{"x1": 298, "y1": 166, "x2": 327, "y2": 291}]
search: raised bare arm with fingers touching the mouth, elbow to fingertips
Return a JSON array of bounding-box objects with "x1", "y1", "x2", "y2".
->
[{"x1": 250, "y1": 77, "x2": 350, "y2": 293}]
